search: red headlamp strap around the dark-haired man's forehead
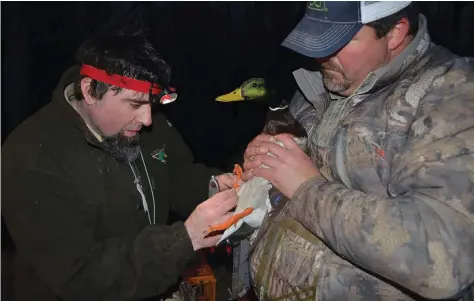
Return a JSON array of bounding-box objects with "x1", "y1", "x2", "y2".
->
[{"x1": 80, "y1": 64, "x2": 163, "y2": 95}]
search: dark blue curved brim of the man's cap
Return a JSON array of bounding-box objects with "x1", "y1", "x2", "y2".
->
[{"x1": 282, "y1": 16, "x2": 362, "y2": 58}]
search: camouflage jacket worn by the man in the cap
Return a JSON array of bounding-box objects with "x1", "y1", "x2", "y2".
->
[{"x1": 290, "y1": 15, "x2": 474, "y2": 301}]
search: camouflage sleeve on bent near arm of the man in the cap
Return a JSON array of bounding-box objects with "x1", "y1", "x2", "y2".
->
[{"x1": 291, "y1": 73, "x2": 474, "y2": 299}]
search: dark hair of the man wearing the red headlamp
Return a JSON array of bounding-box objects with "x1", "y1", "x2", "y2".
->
[{"x1": 72, "y1": 29, "x2": 170, "y2": 100}]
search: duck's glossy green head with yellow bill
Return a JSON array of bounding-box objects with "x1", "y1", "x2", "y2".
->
[{"x1": 216, "y1": 78, "x2": 268, "y2": 102}]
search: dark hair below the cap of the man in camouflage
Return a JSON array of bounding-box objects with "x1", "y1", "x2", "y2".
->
[{"x1": 366, "y1": 4, "x2": 419, "y2": 39}]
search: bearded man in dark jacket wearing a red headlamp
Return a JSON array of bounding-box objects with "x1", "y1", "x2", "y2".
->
[{"x1": 2, "y1": 28, "x2": 236, "y2": 301}]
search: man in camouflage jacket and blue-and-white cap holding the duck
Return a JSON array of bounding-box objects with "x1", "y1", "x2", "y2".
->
[{"x1": 244, "y1": 2, "x2": 474, "y2": 301}]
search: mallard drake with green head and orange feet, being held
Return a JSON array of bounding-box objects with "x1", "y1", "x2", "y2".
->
[{"x1": 208, "y1": 78, "x2": 307, "y2": 244}]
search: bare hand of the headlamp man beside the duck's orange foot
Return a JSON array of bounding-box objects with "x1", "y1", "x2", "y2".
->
[{"x1": 184, "y1": 189, "x2": 237, "y2": 251}]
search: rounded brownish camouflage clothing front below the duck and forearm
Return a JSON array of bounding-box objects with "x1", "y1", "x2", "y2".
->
[{"x1": 250, "y1": 212, "x2": 326, "y2": 301}]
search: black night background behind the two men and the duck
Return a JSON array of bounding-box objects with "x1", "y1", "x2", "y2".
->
[{"x1": 1, "y1": 2, "x2": 474, "y2": 300}]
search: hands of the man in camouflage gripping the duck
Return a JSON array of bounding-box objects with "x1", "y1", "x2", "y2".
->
[{"x1": 244, "y1": 134, "x2": 323, "y2": 198}]
